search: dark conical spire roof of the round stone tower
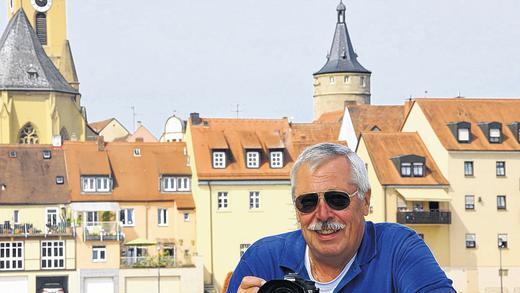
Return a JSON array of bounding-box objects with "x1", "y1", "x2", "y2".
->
[{"x1": 314, "y1": 1, "x2": 370, "y2": 75}]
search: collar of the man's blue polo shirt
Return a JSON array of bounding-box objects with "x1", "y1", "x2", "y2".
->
[{"x1": 280, "y1": 221, "x2": 377, "y2": 279}]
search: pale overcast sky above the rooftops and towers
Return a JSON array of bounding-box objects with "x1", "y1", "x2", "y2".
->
[{"x1": 0, "y1": 0, "x2": 520, "y2": 136}]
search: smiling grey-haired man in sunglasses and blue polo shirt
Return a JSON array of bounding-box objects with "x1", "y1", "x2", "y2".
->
[{"x1": 228, "y1": 143, "x2": 455, "y2": 293}]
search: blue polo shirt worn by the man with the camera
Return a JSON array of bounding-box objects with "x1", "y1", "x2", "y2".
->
[{"x1": 227, "y1": 222, "x2": 455, "y2": 293}]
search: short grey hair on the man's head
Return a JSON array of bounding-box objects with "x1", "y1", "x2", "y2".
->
[{"x1": 291, "y1": 143, "x2": 370, "y2": 199}]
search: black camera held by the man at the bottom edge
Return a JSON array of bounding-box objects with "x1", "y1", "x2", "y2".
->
[{"x1": 258, "y1": 273, "x2": 320, "y2": 293}]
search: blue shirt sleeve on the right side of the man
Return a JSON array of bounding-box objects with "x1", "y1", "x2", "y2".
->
[{"x1": 393, "y1": 232, "x2": 456, "y2": 293}]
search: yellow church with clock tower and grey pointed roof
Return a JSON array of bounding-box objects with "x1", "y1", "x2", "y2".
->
[{"x1": 0, "y1": 0, "x2": 87, "y2": 144}]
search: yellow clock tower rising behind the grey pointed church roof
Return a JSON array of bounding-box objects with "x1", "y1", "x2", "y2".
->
[{"x1": 7, "y1": 0, "x2": 79, "y2": 90}]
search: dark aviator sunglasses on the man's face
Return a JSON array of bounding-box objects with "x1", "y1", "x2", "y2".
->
[{"x1": 294, "y1": 190, "x2": 358, "y2": 214}]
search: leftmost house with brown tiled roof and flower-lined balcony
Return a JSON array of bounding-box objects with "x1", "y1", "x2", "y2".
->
[{"x1": 0, "y1": 145, "x2": 79, "y2": 293}]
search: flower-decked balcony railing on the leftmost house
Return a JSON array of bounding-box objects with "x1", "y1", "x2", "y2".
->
[{"x1": 0, "y1": 221, "x2": 76, "y2": 237}]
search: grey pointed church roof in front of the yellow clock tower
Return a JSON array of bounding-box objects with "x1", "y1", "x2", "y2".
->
[{"x1": 0, "y1": 9, "x2": 78, "y2": 94}]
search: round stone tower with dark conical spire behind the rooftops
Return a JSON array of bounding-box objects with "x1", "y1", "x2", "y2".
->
[{"x1": 314, "y1": 1, "x2": 371, "y2": 120}]
